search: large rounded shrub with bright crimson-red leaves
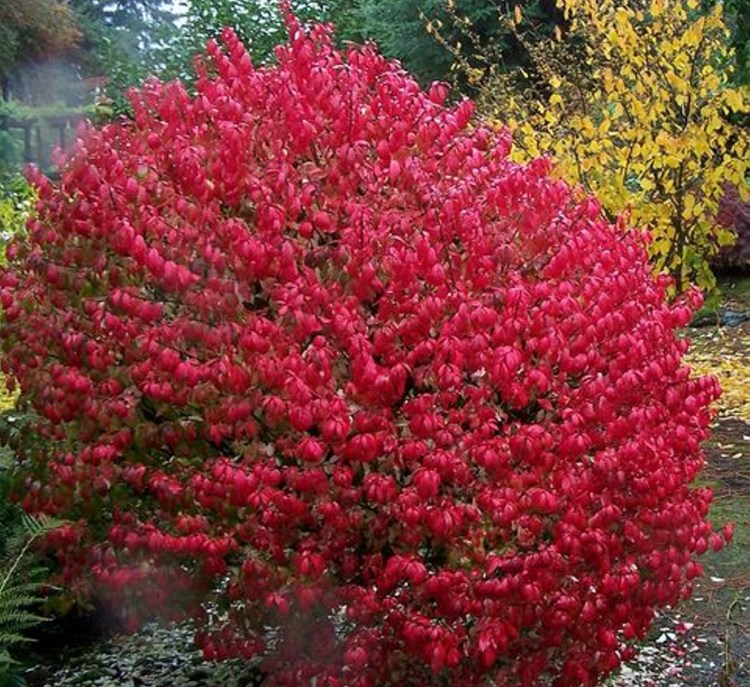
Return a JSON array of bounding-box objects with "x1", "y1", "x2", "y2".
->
[{"x1": 0, "y1": 10, "x2": 722, "y2": 687}]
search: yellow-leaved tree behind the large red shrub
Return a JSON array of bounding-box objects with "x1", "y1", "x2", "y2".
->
[{"x1": 473, "y1": 0, "x2": 750, "y2": 289}]
